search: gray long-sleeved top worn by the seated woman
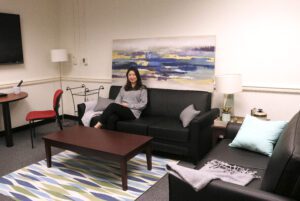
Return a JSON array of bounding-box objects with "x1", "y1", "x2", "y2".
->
[{"x1": 115, "y1": 86, "x2": 148, "y2": 119}]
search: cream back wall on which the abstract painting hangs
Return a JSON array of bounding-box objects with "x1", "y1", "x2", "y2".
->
[{"x1": 61, "y1": 0, "x2": 300, "y2": 120}]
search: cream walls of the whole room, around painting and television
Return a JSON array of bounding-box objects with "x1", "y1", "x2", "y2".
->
[{"x1": 0, "y1": 0, "x2": 300, "y2": 130}]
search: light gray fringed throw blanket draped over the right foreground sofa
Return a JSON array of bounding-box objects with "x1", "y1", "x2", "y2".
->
[{"x1": 166, "y1": 160, "x2": 260, "y2": 191}]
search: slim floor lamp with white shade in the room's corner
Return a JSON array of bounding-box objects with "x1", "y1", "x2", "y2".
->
[{"x1": 51, "y1": 49, "x2": 68, "y2": 123}]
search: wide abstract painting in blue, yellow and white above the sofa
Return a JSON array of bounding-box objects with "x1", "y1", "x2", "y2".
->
[{"x1": 112, "y1": 36, "x2": 215, "y2": 91}]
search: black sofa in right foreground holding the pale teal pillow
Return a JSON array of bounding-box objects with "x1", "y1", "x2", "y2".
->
[{"x1": 169, "y1": 112, "x2": 300, "y2": 201}]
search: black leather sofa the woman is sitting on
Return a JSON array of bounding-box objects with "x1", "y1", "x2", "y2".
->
[{"x1": 78, "y1": 86, "x2": 219, "y2": 162}]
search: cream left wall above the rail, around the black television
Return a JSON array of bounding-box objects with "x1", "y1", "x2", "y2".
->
[{"x1": 0, "y1": 0, "x2": 59, "y2": 84}]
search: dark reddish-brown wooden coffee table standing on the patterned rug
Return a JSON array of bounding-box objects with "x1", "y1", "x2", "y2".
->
[{"x1": 43, "y1": 126, "x2": 152, "y2": 190}]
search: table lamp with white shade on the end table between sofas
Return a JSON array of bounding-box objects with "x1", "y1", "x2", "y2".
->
[{"x1": 216, "y1": 74, "x2": 242, "y2": 121}]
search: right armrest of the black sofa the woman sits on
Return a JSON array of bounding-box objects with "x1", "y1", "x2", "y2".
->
[{"x1": 189, "y1": 108, "x2": 219, "y2": 164}]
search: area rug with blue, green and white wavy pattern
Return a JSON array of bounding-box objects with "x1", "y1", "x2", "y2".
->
[{"x1": 0, "y1": 151, "x2": 172, "y2": 201}]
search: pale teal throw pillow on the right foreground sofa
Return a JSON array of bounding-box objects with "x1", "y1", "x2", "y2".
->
[{"x1": 229, "y1": 115, "x2": 287, "y2": 156}]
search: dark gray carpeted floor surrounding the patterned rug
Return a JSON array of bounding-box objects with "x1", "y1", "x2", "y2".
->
[{"x1": 0, "y1": 120, "x2": 195, "y2": 201}]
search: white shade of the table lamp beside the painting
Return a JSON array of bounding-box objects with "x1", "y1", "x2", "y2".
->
[{"x1": 215, "y1": 74, "x2": 242, "y2": 94}]
